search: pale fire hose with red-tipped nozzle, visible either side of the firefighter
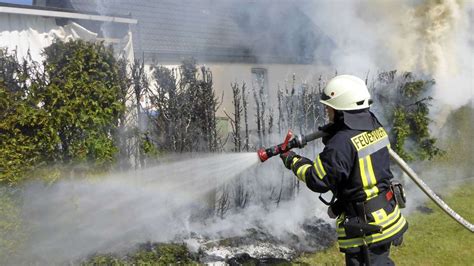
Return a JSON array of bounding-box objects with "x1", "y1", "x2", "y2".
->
[{"x1": 257, "y1": 131, "x2": 474, "y2": 233}]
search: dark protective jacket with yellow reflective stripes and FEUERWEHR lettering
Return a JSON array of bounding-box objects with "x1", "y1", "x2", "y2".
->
[{"x1": 291, "y1": 110, "x2": 408, "y2": 252}]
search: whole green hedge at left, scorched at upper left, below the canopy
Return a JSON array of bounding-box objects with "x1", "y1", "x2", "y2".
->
[{"x1": 0, "y1": 40, "x2": 125, "y2": 185}]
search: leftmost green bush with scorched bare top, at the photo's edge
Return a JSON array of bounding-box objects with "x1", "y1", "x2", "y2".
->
[{"x1": 0, "y1": 50, "x2": 58, "y2": 185}]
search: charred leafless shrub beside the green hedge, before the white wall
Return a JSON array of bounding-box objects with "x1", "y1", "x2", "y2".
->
[{"x1": 150, "y1": 59, "x2": 219, "y2": 152}]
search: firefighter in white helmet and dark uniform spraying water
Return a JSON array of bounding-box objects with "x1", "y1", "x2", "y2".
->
[{"x1": 280, "y1": 75, "x2": 408, "y2": 265}]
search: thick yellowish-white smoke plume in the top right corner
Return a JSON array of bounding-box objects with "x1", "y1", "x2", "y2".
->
[{"x1": 389, "y1": 0, "x2": 474, "y2": 112}]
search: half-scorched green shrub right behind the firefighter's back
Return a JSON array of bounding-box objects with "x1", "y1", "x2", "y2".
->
[{"x1": 373, "y1": 70, "x2": 443, "y2": 161}]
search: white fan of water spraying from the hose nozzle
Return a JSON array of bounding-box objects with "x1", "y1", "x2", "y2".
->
[{"x1": 9, "y1": 153, "x2": 254, "y2": 264}]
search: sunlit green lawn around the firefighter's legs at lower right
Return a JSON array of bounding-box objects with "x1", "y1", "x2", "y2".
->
[{"x1": 296, "y1": 183, "x2": 474, "y2": 265}]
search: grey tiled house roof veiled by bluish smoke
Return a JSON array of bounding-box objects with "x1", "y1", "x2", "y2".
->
[{"x1": 39, "y1": 0, "x2": 331, "y2": 64}]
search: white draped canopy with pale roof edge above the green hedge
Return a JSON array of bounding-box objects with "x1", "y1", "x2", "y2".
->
[{"x1": 0, "y1": 3, "x2": 137, "y2": 61}]
